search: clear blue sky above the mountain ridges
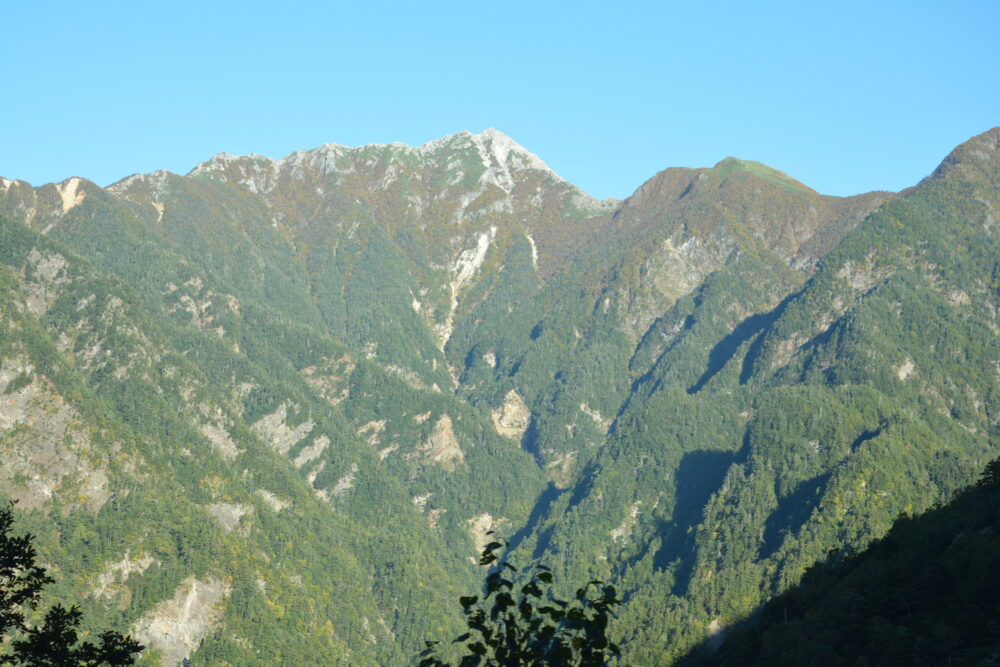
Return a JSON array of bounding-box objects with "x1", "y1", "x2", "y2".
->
[{"x1": 0, "y1": 0, "x2": 1000, "y2": 197}]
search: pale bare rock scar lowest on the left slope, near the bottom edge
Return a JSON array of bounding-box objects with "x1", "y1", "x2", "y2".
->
[{"x1": 132, "y1": 577, "x2": 230, "y2": 667}]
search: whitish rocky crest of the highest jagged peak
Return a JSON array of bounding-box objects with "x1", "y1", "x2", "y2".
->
[{"x1": 180, "y1": 129, "x2": 602, "y2": 225}]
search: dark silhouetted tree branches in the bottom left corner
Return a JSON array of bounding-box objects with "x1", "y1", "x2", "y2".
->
[{"x1": 0, "y1": 507, "x2": 143, "y2": 667}]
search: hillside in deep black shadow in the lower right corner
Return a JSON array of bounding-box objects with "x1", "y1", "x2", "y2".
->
[{"x1": 684, "y1": 459, "x2": 1000, "y2": 667}]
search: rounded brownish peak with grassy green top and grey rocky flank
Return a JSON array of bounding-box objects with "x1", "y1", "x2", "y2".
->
[{"x1": 592, "y1": 158, "x2": 891, "y2": 340}]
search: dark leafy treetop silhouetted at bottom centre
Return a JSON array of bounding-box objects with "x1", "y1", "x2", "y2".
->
[{"x1": 420, "y1": 532, "x2": 621, "y2": 667}]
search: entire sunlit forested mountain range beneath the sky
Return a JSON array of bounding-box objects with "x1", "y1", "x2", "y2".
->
[{"x1": 0, "y1": 128, "x2": 1000, "y2": 665}]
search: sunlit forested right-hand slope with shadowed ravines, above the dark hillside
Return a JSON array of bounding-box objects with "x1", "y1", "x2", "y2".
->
[{"x1": 524, "y1": 130, "x2": 1000, "y2": 663}]
